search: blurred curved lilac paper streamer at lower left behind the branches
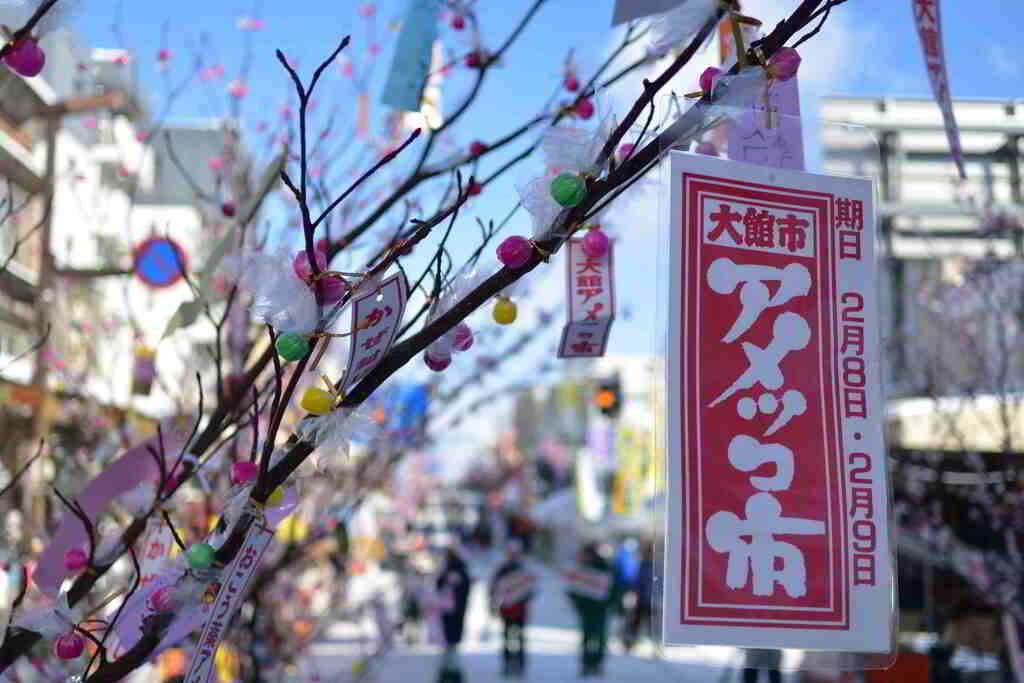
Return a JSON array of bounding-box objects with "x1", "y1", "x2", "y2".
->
[{"x1": 32, "y1": 418, "x2": 191, "y2": 596}]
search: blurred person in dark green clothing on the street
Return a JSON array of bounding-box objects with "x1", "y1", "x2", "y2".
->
[{"x1": 566, "y1": 544, "x2": 618, "y2": 678}]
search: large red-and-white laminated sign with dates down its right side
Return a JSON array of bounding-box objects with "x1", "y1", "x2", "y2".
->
[{"x1": 664, "y1": 153, "x2": 894, "y2": 652}]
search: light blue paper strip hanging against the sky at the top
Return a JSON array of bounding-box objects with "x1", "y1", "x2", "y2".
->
[{"x1": 381, "y1": 0, "x2": 439, "y2": 112}]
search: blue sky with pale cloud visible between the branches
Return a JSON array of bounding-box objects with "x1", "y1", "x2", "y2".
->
[{"x1": 61, "y1": 0, "x2": 1024, "y2": 458}]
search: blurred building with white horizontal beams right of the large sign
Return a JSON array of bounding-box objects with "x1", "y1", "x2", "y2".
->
[{"x1": 821, "y1": 97, "x2": 1024, "y2": 396}]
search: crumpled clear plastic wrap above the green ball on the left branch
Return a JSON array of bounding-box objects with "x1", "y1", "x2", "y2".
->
[{"x1": 221, "y1": 249, "x2": 319, "y2": 334}]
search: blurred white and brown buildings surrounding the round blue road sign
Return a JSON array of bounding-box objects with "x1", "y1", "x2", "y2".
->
[{"x1": 0, "y1": 21, "x2": 235, "y2": 450}]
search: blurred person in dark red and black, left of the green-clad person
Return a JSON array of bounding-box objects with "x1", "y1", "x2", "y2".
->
[{"x1": 488, "y1": 539, "x2": 535, "y2": 678}]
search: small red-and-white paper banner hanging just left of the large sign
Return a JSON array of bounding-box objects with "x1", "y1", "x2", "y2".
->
[{"x1": 558, "y1": 240, "x2": 615, "y2": 358}]
